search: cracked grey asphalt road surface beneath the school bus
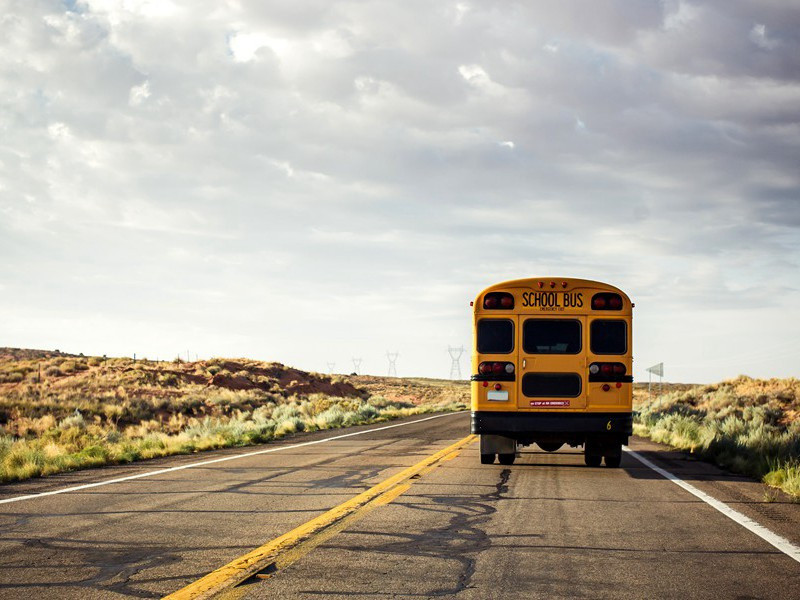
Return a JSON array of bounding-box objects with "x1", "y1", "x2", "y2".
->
[{"x1": 0, "y1": 413, "x2": 800, "y2": 600}]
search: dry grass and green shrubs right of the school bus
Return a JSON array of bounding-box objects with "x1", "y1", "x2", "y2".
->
[{"x1": 634, "y1": 376, "x2": 800, "y2": 499}]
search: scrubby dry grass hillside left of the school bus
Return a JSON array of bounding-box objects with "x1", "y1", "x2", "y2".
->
[{"x1": 0, "y1": 349, "x2": 469, "y2": 481}]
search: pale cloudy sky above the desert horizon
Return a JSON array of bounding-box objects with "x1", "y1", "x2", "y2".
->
[{"x1": 0, "y1": 0, "x2": 800, "y2": 382}]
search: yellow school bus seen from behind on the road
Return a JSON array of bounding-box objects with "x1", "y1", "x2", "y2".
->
[{"x1": 471, "y1": 277, "x2": 633, "y2": 467}]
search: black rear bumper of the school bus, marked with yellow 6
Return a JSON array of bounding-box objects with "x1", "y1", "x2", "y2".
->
[{"x1": 471, "y1": 411, "x2": 633, "y2": 442}]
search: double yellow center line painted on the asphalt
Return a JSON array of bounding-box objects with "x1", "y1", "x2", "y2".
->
[{"x1": 165, "y1": 435, "x2": 477, "y2": 600}]
